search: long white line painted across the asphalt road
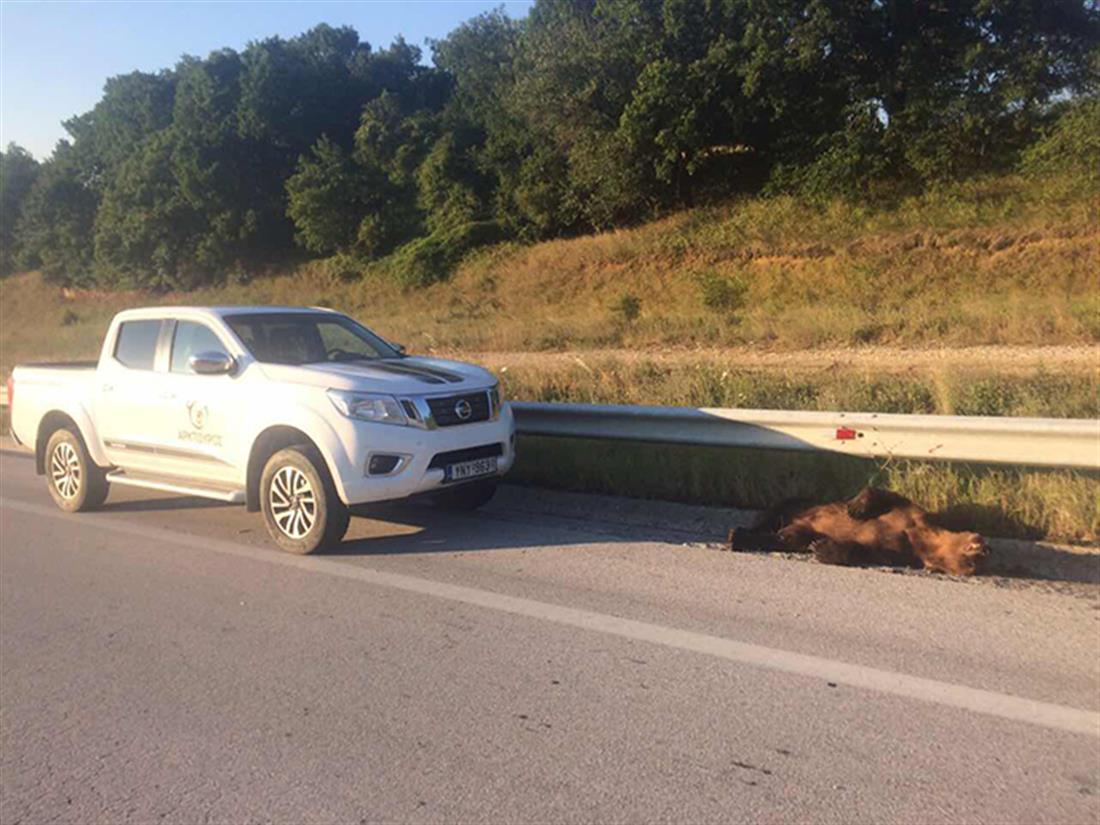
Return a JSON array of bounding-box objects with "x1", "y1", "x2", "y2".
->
[{"x1": 0, "y1": 498, "x2": 1100, "y2": 737}]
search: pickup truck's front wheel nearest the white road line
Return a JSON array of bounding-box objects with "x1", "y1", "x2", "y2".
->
[{"x1": 260, "y1": 444, "x2": 351, "y2": 556}]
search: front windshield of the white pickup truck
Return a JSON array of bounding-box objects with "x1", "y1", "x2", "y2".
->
[{"x1": 226, "y1": 312, "x2": 400, "y2": 365}]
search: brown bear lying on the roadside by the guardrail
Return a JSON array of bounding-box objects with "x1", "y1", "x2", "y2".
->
[{"x1": 729, "y1": 487, "x2": 989, "y2": 575}]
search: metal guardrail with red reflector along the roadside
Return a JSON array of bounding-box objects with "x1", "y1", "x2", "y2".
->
[{"x1": 512, "y1": 402, "x2": 1100, "y2": 470}]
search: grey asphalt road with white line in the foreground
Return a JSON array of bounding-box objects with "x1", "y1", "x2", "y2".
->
[{"x1": 0, "y1": 454, "x2": 1100, "y2": 825}]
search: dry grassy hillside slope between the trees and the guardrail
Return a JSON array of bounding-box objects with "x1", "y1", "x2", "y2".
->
[{"x1": 0, "y1": 177, "x2": 1100, "y2": 369}]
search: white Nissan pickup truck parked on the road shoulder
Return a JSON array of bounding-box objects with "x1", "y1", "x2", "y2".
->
[{"x1": 9, "y1": 307, "x2": 515, "y2": 553}]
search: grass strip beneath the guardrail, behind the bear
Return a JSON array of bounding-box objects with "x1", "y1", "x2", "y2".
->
[{"x1": 512, "y1": 436, "x2": 1100, "y2": 543}]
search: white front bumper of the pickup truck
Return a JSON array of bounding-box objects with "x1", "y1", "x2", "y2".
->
[{"x1": 332, "y1": 405, "x2": 516, "y2": 505}]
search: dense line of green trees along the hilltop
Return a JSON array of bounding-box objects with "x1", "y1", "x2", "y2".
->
[{"x1": 0, "y1": 0, "x2": 1100, "y2": 288}]
